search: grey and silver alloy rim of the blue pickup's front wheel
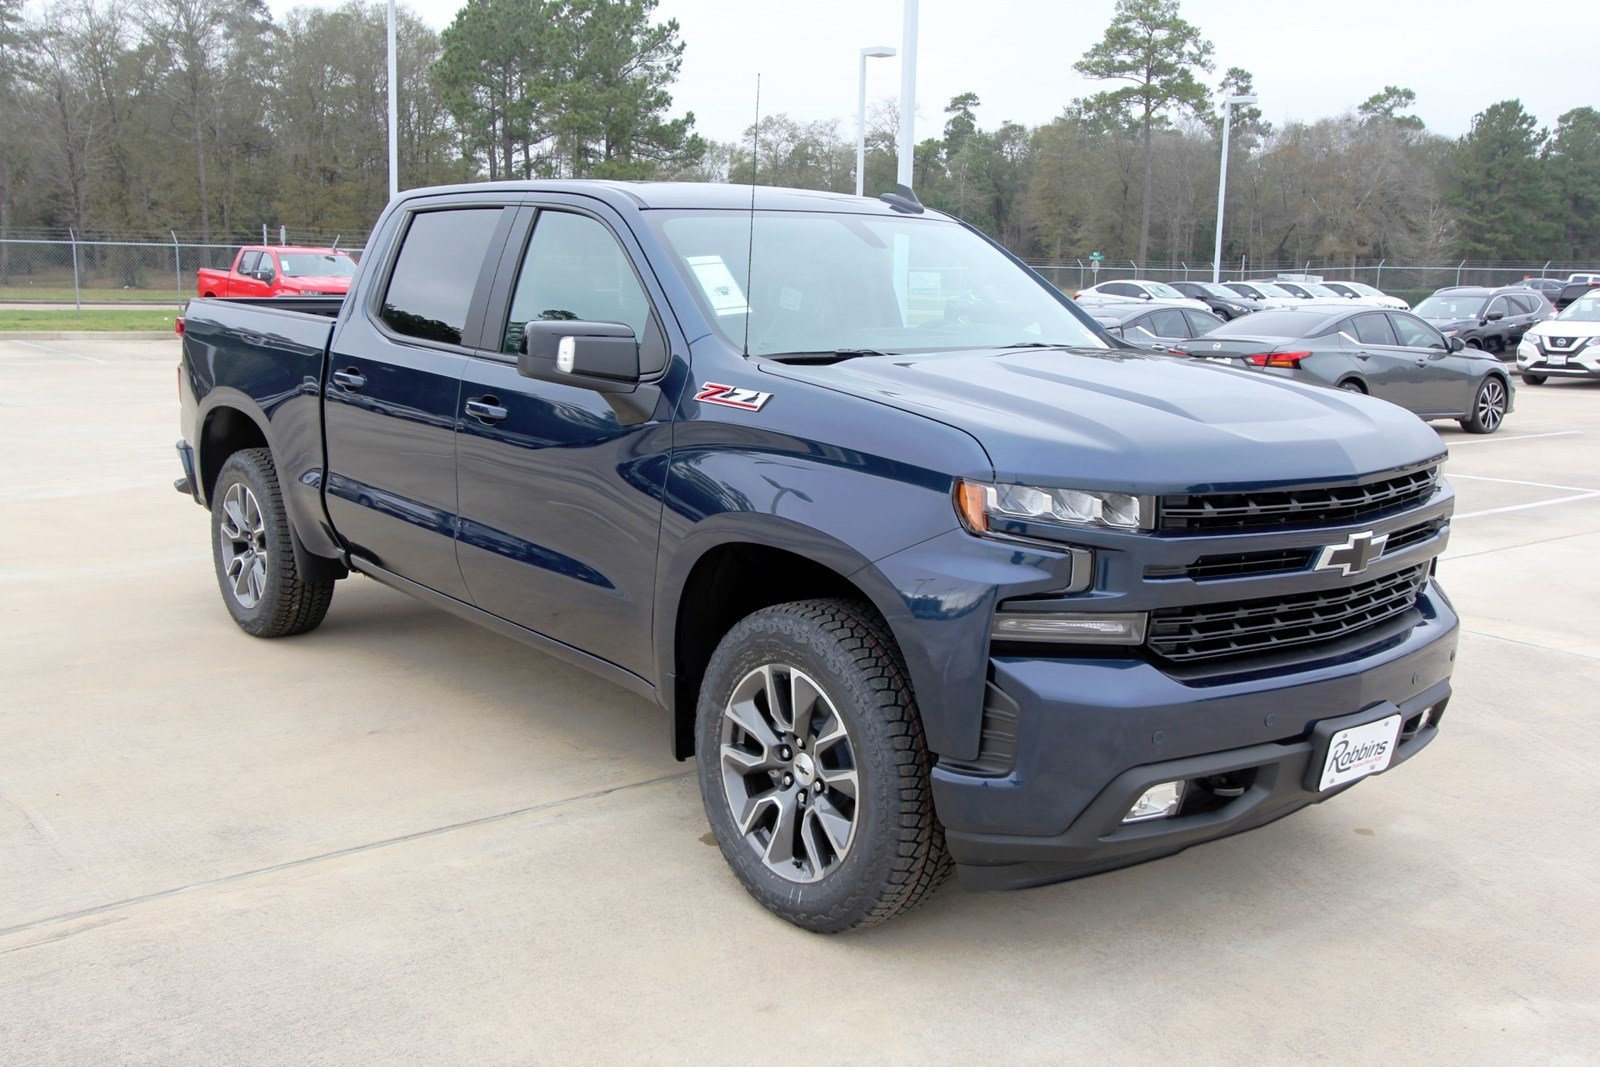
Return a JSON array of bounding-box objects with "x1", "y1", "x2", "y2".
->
[{"x1": 718, "y1": 662, "x2": 861, "y2": 883}]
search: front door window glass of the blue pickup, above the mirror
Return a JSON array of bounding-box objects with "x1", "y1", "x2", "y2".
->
[{"x1": 501, "y1": 211, "x2": 650, "y2": 352}]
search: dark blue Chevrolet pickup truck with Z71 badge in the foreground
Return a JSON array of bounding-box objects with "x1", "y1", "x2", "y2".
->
[{"x1": 178, "y1": 181, "x2": 1458, "y2": 931}]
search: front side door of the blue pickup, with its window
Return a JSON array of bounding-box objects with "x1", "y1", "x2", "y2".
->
[{"x1": 456, "y1": 204, "x2": 672, "y2": 673}]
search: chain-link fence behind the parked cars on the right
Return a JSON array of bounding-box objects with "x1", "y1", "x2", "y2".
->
[{"x1": 1030, "y1": 259, "x2": 1597, "y2": 302}]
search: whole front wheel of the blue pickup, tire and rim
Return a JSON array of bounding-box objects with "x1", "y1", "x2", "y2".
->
[{"x1": 694, "y1": 600, "x2": 950, "y2": 933}]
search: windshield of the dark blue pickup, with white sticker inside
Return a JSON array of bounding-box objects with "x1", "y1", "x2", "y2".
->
[{"x1": 645, "y1": 211, "x2": 1106, "y2": 355}]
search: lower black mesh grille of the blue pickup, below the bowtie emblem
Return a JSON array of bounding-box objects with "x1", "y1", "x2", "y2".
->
[{"x1": 1146, "y1": 563, "x2": 1427, "y2": 662}]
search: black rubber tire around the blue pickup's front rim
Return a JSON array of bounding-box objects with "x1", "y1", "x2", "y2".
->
[{"x1": 694, "y1": 600, "x2": 952, "y2": 933}]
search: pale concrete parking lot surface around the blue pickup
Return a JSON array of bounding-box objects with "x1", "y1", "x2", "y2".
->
[{"x1": 0, "y1": 338, "x2": 1600, "y2": 1064}]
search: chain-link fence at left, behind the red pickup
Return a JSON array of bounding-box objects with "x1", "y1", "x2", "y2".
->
[{"x1": 0, "y1": 238, "x2": 360, "y2": 307}]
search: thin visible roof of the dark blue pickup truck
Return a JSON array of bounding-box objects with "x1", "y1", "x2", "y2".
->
[{"x1": 400, "y1": 178, "x2": 947, "y2": 219}]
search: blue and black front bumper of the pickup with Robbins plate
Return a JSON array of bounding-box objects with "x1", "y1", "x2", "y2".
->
[{"x1": 933, "y1": 582, "x2": 1459, "y2": 889}]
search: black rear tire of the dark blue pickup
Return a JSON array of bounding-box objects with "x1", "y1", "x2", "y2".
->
[{"x1": 211, "y1": 448, "x2": 333, "y2": 637}]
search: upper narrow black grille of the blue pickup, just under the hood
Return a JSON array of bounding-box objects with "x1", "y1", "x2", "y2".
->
[{"x1": 1157, "y1": 467, "x2": 1438, "y2": 533}]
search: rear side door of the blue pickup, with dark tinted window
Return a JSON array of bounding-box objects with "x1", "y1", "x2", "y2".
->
[{"x1": 323, "y1": 198, "x2": 515, "y2": 600}]
